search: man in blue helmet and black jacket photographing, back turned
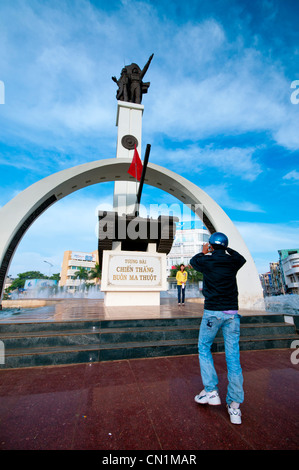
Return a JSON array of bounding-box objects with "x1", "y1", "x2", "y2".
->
[{"x1": 190, "y1": 232, "x2": 246, "y2": 424}]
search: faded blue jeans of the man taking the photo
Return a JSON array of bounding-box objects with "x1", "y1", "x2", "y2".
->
[{"x1": 198, "y1": 310, "x2": 244, "y2": 404}]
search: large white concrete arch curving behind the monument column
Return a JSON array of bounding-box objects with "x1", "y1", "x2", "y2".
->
[{"x1": 0, "y1": 158, "x2": 263, "y2": 308}]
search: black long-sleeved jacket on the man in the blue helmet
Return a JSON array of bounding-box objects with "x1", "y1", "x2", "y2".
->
[{"x1": 190, "y1": 248, "x2": 246, "y2": 311}]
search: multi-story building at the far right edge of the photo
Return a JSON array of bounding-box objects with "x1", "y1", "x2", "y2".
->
[{"x1": 278, "y1": 248, "x2": 299, "y2": 294}]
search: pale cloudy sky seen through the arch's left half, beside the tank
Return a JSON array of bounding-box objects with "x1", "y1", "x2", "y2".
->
[{"x1": 9, "y1": 190, "x2": 112, "y2": 276}]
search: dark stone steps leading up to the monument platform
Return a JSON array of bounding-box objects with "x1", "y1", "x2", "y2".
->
[{"x1": 0, "y1": 314, "x2": 299, "y2": 369}]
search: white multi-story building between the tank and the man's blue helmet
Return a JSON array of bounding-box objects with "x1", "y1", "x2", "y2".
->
[{"x1": 166, "y1": 228, "x2": 210, "y2": 276}]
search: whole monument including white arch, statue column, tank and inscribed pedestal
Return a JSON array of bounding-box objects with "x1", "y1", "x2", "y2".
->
[{"x1": 0, "y1": 55, "x2": 263, "y2": 309}]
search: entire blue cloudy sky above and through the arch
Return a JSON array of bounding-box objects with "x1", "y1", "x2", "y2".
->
[{"x1": 0, "y1": 0, "x2": 299, "y2": 276}]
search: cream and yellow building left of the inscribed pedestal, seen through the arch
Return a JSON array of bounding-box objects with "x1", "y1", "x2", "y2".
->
[{"x1": 59, "y1": 250, "x2": 99, "y2": 290}]
